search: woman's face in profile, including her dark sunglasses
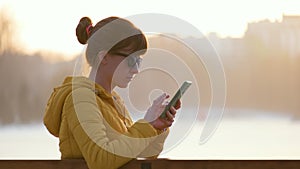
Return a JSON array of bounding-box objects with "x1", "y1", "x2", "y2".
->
[{"x1": 109, "y1": 50, "x2": 141, "y2": 88}]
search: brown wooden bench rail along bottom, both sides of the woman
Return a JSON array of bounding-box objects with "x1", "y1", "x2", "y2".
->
[{"x1": 0, "y1": 159, "x2": 300, "y2": 169}]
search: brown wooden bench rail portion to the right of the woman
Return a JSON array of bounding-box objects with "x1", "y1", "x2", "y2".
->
[{"x1": 121, "y1": 159, "x2": 300, "y2": 169}]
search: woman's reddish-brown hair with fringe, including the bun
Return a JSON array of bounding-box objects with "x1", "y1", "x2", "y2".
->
[{"x1": 76, "y1": 17, "x2": 147, "y2": 66}]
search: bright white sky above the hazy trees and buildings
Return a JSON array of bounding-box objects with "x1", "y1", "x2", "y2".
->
[{"x1": 0, "y1": 0, "x2": 300, "y2": 55}]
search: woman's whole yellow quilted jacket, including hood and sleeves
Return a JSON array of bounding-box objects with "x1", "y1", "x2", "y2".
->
[{"x1": 44, "y1": 77, "x2": 168, "y2": 169}]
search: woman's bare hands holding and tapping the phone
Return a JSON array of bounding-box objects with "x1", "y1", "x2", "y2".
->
[{"x1": 144, "y1": 93, "x2": 181, "y2": 130}]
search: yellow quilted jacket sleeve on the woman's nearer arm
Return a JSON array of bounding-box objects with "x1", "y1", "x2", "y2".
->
[{"x1": 64, "y1": 89, "x2": 166, "y2": 169}]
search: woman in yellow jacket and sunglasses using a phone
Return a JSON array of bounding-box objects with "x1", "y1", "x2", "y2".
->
[{"x1": 44, "y1": 17, "x2": 180, "y2": 169}]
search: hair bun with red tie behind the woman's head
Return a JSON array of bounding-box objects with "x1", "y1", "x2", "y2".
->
[{"x1": 76, "y1": 17, "x2": 93, "y2": 44}]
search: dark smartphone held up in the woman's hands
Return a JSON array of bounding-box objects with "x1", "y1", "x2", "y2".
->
[{"x1": 160, "y1": 81, "x2": 192, "y2": 118}]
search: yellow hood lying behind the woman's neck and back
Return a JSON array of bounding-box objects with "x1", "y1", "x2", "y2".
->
[{"x1": 44, "y1": 77, "x2": 112, "y2": 137}]
